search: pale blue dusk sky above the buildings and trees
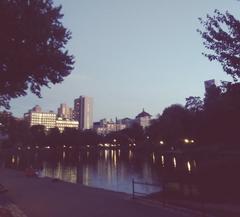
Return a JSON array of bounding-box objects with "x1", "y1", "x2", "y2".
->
[{"x1": 8, "y1": 0, "x2": 240, "y2": 121}]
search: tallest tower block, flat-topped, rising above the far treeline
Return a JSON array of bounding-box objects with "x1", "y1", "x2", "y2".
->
[{"x1": 74, "y1": 96, "x2": 93, "y2": 130}]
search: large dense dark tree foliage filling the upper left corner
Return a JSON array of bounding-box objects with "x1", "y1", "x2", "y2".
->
[{"x1": 0, "y1": 0, "x2": 74, "y2": 108}]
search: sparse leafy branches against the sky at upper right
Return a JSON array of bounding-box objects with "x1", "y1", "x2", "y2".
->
[{"x1": 198, "y1": 10, "x2": 240, "y2": 81}]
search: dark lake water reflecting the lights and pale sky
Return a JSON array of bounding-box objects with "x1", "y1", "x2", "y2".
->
[{"x1": 5, "y1": 149, "x2": 197, "y2": 193}]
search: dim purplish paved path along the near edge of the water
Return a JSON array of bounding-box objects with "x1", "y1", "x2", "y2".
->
[{"x1": 0, "y1": 169, "x2": 200, "y2": 217}]
